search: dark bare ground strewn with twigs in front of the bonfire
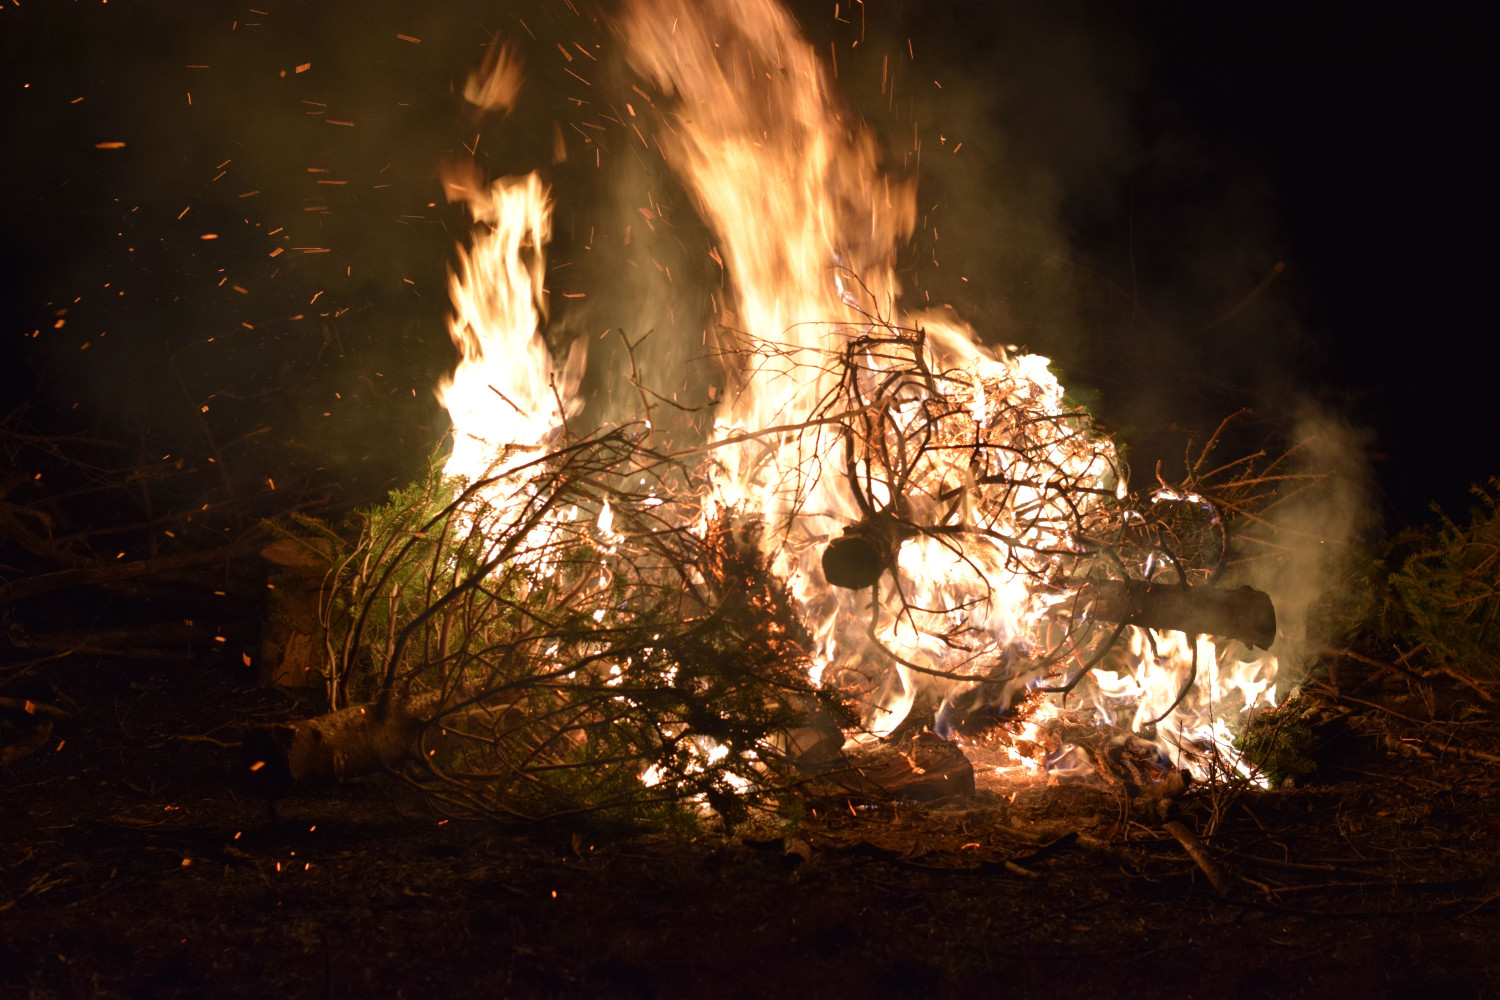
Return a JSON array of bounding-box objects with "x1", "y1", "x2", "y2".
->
[{"x1": 0, "y1": 653, "x2": 1500, "y2": 1000}]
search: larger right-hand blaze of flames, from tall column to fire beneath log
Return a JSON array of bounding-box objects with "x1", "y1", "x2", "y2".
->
[{"x1": 623, "y1": 0, "x2": 1275, "y2": 773}]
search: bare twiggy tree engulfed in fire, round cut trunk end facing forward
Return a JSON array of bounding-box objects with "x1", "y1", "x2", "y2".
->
[{"x1": 699, "y1": 313, "x2": 1280, "y2": 758}]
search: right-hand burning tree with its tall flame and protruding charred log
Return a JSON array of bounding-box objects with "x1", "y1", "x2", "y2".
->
[{"x1": 623, "y1": 0, "x2": 1275, "y2": 766}]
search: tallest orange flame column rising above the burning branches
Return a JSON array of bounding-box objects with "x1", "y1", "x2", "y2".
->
[{"x1": 624, "y1": 0, "x2": 917, "y2": 513}]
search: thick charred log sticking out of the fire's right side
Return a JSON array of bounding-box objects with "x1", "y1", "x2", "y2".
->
[{"x1": 1079, "y1": 580, "x2": 1277, "y2": 649}]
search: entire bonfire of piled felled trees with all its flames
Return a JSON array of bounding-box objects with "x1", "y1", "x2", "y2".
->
[{"x1": 252, "y1": 0, "x2": 1286, "y2": 817}]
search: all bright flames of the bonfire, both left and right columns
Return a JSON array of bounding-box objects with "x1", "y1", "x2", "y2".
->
[{"x1": 438, "y1": 0, "x2": 1277, "y2": 785}]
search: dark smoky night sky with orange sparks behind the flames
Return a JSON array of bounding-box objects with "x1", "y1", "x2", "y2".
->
[{"x1": 0, "y1": 0, "x2": 1500, "y2": 525}]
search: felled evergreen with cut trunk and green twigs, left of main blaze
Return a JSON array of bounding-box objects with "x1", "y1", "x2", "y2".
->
[{"x1": 248, "y1": 430, "x2": 846, "y2": 820}]
